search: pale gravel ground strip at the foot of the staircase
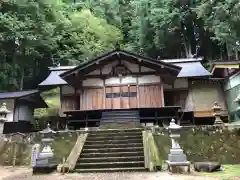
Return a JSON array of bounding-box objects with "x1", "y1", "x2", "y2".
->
[{"x1": 0, "y1": 167, "x2": 217, "y2": 180}]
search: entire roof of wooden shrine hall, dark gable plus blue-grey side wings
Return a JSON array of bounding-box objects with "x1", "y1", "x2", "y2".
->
[{"x1": 39, "y1": 50, "x2": 212, "y2": 86}]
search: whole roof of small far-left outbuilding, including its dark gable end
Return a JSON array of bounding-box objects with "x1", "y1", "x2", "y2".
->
[{"x1": 0, "y1": 90, "x2": 48, "y2": 108}]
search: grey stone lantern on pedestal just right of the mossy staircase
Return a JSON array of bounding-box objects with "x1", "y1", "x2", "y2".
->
[{"x1": 166, "y1": 119, "x2": 190, "y2": 172}]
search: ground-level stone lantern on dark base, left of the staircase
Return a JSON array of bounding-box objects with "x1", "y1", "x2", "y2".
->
[{"x1": 33, "y1": 123, "x2": 57, "y2": 173}]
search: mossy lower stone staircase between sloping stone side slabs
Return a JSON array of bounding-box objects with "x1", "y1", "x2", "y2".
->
[{"x1": 75, "y1": 128, "x2": 145, "y2": 172}]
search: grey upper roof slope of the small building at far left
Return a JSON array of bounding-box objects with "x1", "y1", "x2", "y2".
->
[{"x1": 0, "y1": 90, "x2": 39, "y2": 99}]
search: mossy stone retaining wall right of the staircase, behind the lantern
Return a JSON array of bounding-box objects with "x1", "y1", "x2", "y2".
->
[{"x1": 154, "y1": 126, "x2": 240, "y2": 164}]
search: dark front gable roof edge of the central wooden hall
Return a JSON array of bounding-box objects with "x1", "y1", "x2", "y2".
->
[{"x1": 60, "y1": 49, "x2": 181, "y2": 79}]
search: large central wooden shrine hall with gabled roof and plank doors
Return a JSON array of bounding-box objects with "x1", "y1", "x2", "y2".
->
[{"x1": 39, "y1": 49, "x2": 229, "y2": 128}]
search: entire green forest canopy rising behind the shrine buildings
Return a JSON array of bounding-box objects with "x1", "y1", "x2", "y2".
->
[{"x1": 0, "y1": 0, "x2": 240, "y2": 91}]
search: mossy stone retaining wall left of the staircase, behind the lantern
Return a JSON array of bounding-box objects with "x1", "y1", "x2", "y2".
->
[{"x1": 0, "y1": 132, "x2": 80, "y2": 165}]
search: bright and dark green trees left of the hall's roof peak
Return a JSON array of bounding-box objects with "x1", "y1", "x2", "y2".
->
[{"x1": 0, "y1": 0, "x2": 122, "y2": 90}]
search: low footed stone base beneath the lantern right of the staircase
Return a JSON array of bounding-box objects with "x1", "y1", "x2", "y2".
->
[{"x1": 166, "y1": 161, "x2": 190, "y2": 173}]
